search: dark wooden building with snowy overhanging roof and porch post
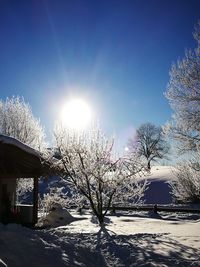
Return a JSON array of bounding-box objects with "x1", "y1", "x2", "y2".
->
[{"x1": 0, "y1": 135, "x2": 51, "y2": 225}]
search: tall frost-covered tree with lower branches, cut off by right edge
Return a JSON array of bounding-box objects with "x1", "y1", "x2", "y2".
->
[{"x1": 165, "y1": 22, "x2": 200, "y2": 202}]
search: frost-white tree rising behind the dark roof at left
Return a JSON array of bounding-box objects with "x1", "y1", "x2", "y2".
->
[{"x1": 0, "y1": 97, "x2": 45, "y2": 199}]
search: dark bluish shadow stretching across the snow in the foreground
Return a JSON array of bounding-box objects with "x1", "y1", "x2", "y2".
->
[{"x1": 0, "y1": 225, "x2": 200, "y2": 267}]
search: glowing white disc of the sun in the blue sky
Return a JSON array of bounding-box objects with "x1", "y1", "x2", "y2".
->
[{"x1": 61, "y1": 98, "x2": 92, "y2": 130}]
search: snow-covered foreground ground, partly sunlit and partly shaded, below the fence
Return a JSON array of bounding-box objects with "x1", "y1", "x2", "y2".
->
[{"x1": 0, "y1": 212, "x2": 200, "y2": 267}]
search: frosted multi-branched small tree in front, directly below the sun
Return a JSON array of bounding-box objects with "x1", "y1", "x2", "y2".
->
[{"x1": 52, "y1": 128, "x2": 146, "y2": 224}]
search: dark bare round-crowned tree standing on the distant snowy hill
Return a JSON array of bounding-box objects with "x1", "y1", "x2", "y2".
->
[{"x1": 128, "y1": 122, "x2": 169, "y2": 169}]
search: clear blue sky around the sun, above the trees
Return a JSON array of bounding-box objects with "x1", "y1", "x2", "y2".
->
[{"x1": 0, "y1": 0, "x2": 200, "y2": 151}]
